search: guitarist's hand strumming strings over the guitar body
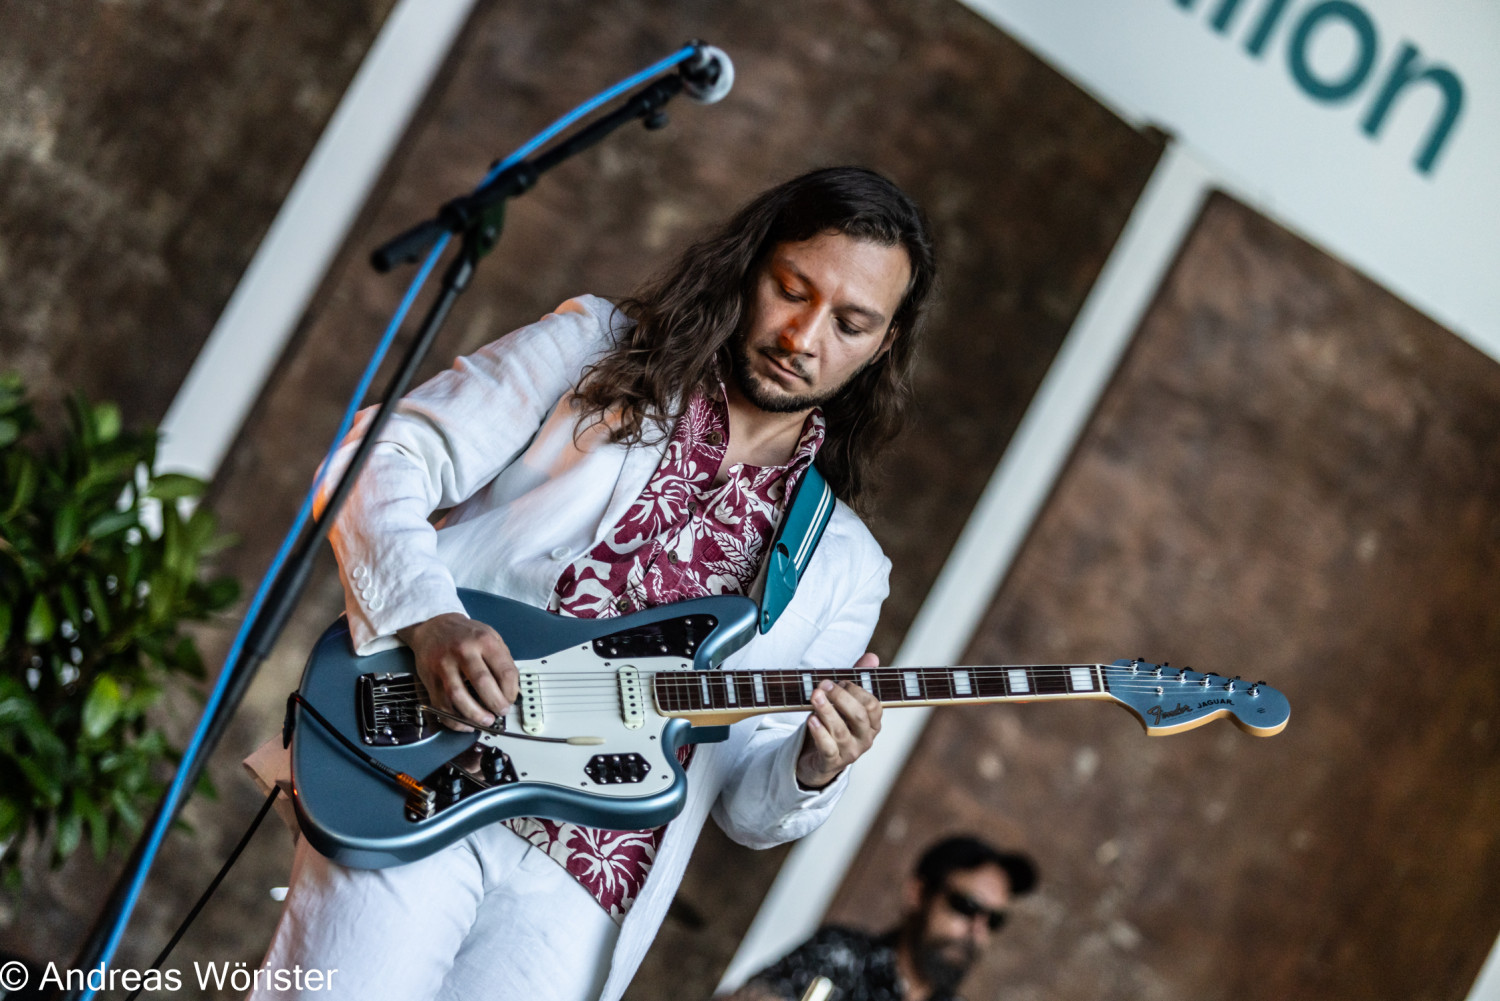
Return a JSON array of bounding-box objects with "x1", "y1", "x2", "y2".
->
[{"x1": 396, "y1": 612, "x2": 521, "y2": 731}]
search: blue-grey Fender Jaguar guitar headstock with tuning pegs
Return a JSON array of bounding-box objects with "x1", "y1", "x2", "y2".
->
[{"x1": 1104, "y1": 657, "x2": 1292, "y2": 737}]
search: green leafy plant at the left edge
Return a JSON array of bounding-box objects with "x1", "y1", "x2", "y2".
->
[{"x1": 0, "y1": 374, "x2": 239, "y2": 881}]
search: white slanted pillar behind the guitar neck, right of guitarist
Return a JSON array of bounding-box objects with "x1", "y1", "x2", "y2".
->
[{"x1": 719, "y1": 144, "x2": 1214, "y2": 992}]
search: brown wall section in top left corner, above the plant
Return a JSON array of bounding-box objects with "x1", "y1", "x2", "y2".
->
[{"x1": 0, "y1": 0, "x2": 393, "y2": 423}]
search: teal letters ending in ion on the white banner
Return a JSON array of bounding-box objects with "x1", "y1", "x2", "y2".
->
[{"x1": 1173, "y1": 0, "x2": 1464, "y2": 176}]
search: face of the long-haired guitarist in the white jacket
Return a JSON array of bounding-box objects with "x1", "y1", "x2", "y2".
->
[{"x1": 735, "y1": 233, "x2": 911, "y2": 413}]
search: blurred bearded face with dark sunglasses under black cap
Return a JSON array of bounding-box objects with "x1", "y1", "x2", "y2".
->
[{"x1": 911, "y1": 864, "x2": 1011, "y2": 990}]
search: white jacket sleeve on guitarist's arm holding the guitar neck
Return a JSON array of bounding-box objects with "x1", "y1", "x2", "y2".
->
[{"x1": 713, "y1": 536, "x2": 891, "y2": 848}]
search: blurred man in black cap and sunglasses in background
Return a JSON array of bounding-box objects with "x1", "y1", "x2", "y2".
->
[{"x1": 725, "y1": 836, "x2": 1038, "y2": 1001}]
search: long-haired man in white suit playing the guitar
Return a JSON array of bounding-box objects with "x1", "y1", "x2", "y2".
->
[{"x1": 252, "y1": 168, "x2": 935, "y2": 1001}]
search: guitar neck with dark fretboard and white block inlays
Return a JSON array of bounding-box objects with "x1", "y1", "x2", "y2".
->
[{"x1": 653, "y1": 663, "x2": 1110, "y2": 725}]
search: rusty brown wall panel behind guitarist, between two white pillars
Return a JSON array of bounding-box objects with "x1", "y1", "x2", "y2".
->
[{"x1": 0, "y1": 0, "x2": 1161, "y2": 998}]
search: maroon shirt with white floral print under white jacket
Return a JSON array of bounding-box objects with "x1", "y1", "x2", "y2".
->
[{"x1": 506, "y1": 392, "x2": 824, "y2": 921}]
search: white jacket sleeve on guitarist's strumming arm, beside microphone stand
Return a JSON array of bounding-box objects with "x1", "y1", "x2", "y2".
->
[{"x1": 318, "y1": 297, "x2": 612, "y2": 654}]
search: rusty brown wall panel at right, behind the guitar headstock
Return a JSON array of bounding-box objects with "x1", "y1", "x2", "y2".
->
[{"x1": 833, "y1": 197, "x2": 1500, "y2": 1001}]
